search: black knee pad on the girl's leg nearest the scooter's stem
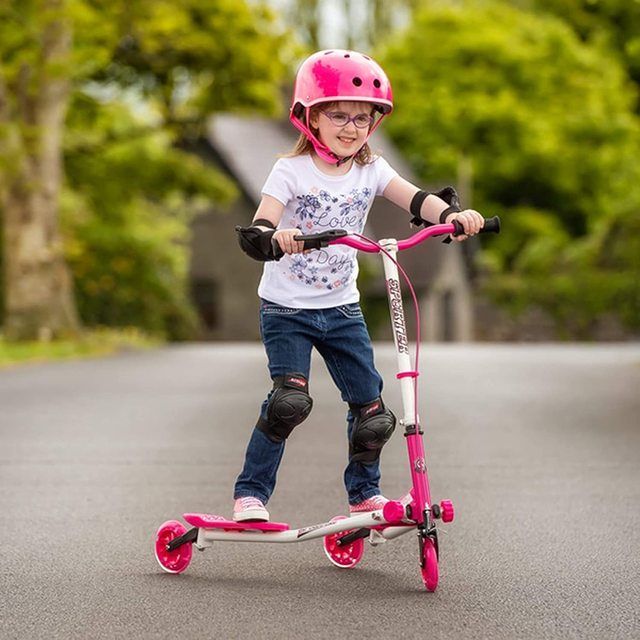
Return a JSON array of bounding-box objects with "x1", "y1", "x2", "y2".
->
[{"x1": 349, "y1": 398, "x2": 396, "y2": 464}]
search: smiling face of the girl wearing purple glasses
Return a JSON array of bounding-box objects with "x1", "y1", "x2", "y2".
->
[{"x1": 309, "y1": 102, "x2": 373, "y2": 158}]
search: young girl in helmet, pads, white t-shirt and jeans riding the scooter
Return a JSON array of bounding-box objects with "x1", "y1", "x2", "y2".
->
[{"x1": 233, "y1": 49, "x2": 484, "y2": 521}]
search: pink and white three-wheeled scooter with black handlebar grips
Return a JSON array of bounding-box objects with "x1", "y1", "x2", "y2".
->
[{"x1": 155, "y1": 217, "x2": 500, "y2": 591}]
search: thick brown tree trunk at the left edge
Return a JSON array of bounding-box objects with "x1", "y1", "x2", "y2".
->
[{"x1": 0, "y1": 0, "x2": 79, "y2": 340}]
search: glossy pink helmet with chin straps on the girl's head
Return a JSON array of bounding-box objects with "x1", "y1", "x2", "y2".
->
[{"x1": 289, "y1": 49, "x2": 393, "y2": 164}]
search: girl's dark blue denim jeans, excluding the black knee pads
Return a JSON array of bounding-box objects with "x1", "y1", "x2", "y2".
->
[{"x1": 234, "y1": 300, "x2": 382, "y2": 504}]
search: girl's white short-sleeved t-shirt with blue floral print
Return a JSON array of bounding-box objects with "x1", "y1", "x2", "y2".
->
[{"x1": 258, "y1": 154, "x2": 398, "y2": 309}]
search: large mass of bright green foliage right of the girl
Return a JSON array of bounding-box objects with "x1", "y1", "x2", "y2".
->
[{"x1": 382, "y1": 2, "x2": 640, "y2": 337}]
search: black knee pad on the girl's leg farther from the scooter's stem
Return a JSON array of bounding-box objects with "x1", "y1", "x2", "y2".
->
[{"x1": 256, "y1": 373, "x2": 313, "y2": 442}]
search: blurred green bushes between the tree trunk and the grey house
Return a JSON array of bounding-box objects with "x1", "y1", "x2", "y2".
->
[{"x1": 63, "y1": 95, "x2": 235, "y2": 339}]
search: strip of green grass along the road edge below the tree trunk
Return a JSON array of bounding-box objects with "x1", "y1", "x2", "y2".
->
[{"x1": 0, "y1": 328, "x2": 162, "y2": 368}]
